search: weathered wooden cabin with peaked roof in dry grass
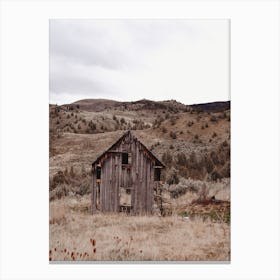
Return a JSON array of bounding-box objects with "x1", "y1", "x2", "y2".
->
[{"x1": 92, "y1": 131, "x2": 165, "y2": 214}]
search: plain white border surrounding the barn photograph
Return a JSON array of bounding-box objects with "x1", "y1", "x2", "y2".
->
[{"x1": 0, "y1": 0, "x2": 280, "y2": 280}]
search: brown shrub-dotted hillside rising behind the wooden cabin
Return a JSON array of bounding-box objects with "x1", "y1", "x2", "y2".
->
[{"x1": 49, "y1": 99, "x2": 230, "y2": 184}]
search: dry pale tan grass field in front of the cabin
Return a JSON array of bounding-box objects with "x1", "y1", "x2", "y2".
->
[{"x1": 49, "y1": 197, "x2": 230, "y2": 261}]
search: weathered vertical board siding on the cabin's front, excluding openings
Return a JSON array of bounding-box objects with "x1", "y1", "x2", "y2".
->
[{"x1": 92, "y1": 133, "x2": 161, "y2": 214}]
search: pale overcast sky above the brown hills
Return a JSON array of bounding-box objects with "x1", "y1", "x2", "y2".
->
[{"x1": 50, "y1": 20, "x2": 229, "y2": 104}]
